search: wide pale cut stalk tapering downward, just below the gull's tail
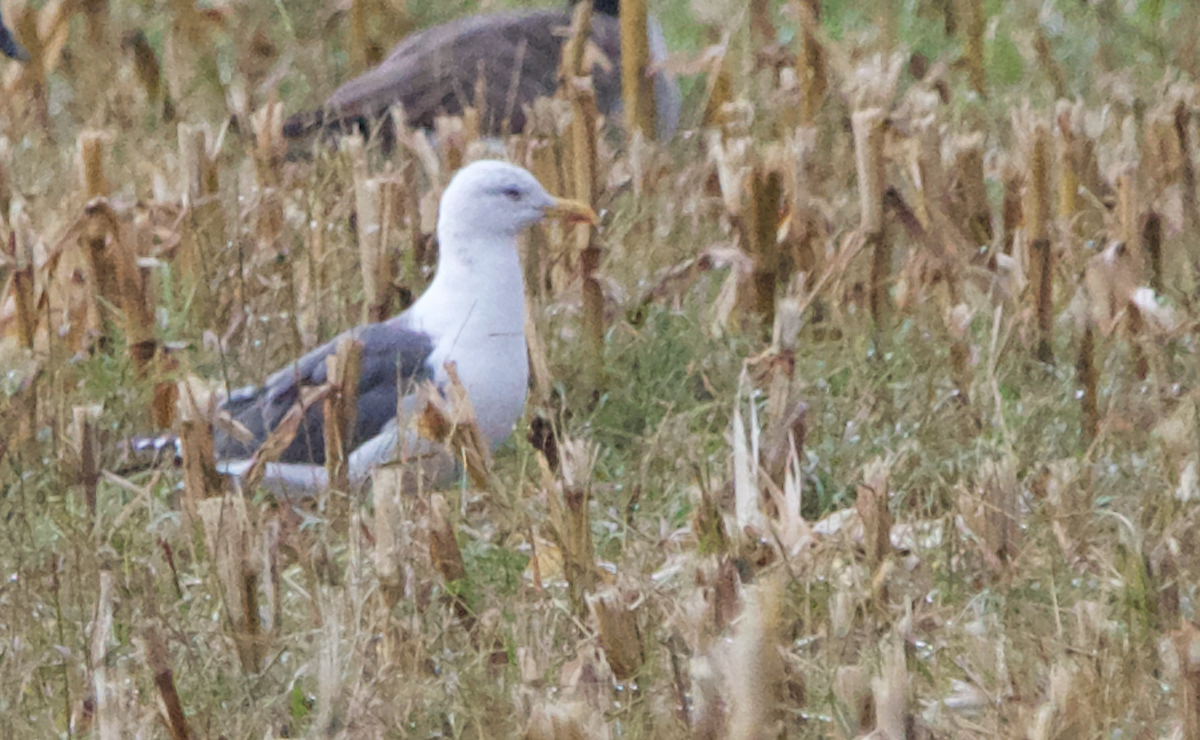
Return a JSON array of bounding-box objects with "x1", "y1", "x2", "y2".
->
[{"x1": 199, "y1": 494, "x2": 264, "y2": 674}]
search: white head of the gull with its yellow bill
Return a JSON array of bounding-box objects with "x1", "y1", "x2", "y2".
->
[{"x1": 438, "y1": 160, "x2": 595, "y2": 245}]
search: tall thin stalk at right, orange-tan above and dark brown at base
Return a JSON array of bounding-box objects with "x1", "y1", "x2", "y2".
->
[{"x1": 1022, "y1": 122, "x2": 1054, "y2": 362}]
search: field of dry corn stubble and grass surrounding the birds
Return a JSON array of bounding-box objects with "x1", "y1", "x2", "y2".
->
[{"x1": 0, "y1": 0, "x2": 1200, "y2": 740}]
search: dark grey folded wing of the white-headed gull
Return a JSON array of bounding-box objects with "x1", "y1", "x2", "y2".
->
[{"x1": 215, "y1": 319, "x2": 433, "y2": 464}]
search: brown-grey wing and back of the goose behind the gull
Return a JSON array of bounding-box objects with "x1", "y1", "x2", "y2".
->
[{"x1": 284, "y1": 11, "x2": 620, "y2": 137}]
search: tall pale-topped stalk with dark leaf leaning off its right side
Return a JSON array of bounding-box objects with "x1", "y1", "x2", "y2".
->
[{"x1": 851, "y1": 108, "x2": 892, "y2": 325}]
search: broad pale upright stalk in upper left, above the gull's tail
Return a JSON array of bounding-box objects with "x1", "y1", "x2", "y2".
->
[{"x1": 178, "y1": 124, "x2": 226, "y2": 326}]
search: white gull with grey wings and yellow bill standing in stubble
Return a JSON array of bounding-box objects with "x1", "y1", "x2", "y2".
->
[{"x1": 151, "y1": 160, "x2": 595, "y2": 495}]
